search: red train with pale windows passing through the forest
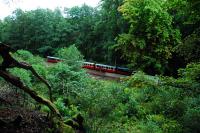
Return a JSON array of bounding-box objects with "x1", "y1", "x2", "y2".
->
[{"x1": 47, "y1": 56, "x2": 132, "y2": 76}]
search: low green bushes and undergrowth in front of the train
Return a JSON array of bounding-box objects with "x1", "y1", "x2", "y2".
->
[{"x1": 1, "y1": 45, "x2": 200, "y2": 133}]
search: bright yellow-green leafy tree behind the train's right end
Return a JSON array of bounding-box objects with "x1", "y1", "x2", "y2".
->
[{"x1": 115, "y1": 0, "x2": 181, "y2": 74}]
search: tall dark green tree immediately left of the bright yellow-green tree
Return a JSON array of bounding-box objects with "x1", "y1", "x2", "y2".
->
[{"x1": 94, "y1": 0, "x2": 128, "y2": 65}]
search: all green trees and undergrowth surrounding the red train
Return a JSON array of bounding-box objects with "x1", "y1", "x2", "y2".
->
[{"x1": 0, "y1": 0, "x2": 200, "y2": 133}]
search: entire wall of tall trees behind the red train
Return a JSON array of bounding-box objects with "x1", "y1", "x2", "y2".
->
[{"x1": 0, "y1": 0, "x2": 200, "y2": 75}]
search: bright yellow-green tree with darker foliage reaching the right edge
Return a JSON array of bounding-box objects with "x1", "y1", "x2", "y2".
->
[{"x1": 116, "y1": 0, "x2": 199, "y2": 74}]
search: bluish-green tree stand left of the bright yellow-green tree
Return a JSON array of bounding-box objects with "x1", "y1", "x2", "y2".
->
[{"x1": 0, "y1": 0, "x2": 125, "y2": 63}]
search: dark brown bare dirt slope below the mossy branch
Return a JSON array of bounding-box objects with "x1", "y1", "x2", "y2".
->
[{"x1": 0, "y1": 83, "x2": 51, "y2": 133}]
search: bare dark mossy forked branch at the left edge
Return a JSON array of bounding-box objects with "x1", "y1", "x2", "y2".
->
[{"x1": 0, "y1": 43, "x2": 60, "y2": 117}]
